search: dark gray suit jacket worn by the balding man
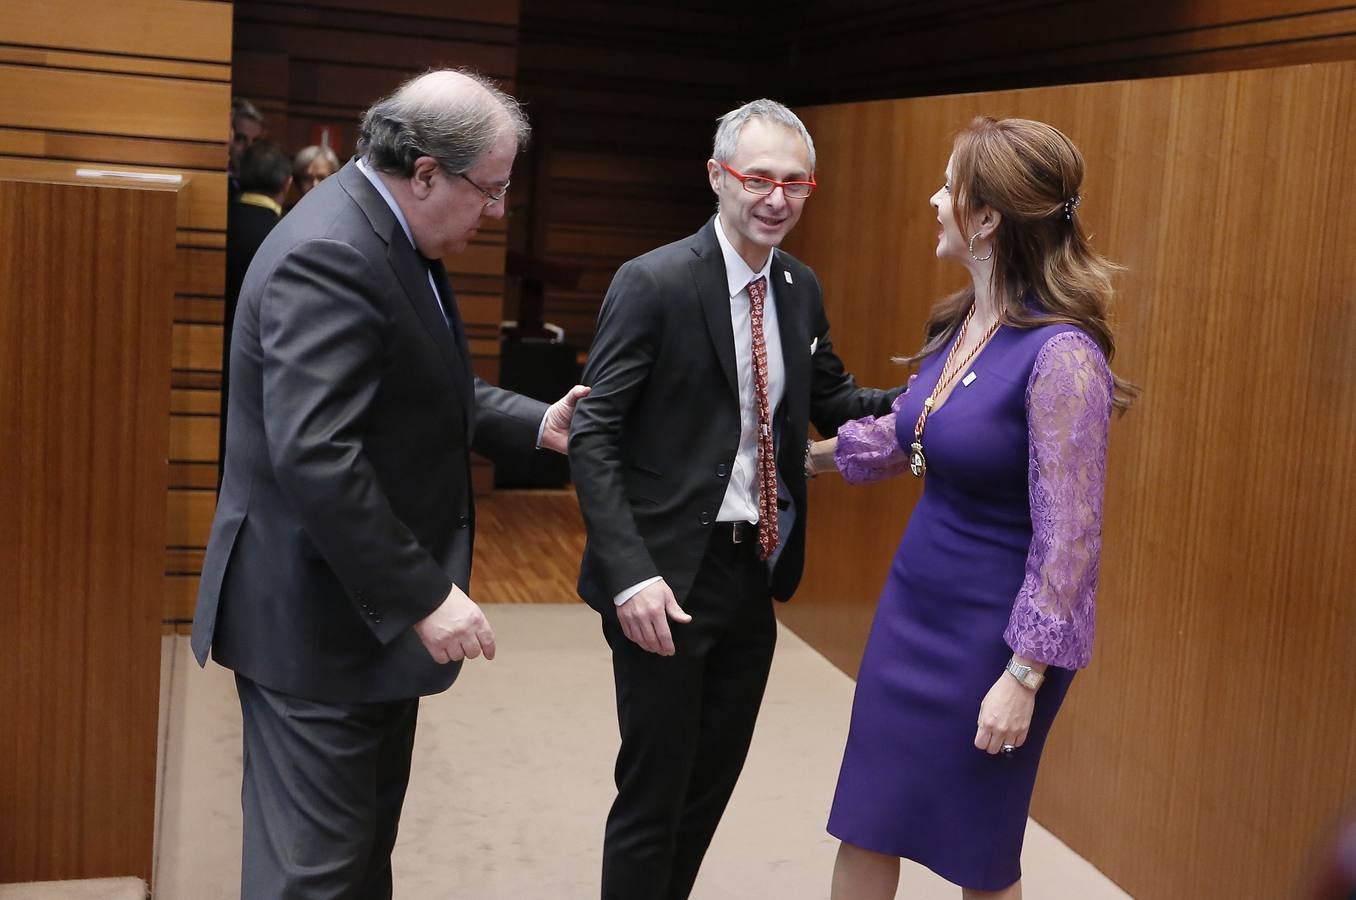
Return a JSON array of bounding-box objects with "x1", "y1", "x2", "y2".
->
[{"x1": 193, "y1": 163, "x2": 545, "y2": 702}]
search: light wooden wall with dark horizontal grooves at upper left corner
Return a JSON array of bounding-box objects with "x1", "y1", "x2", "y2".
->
[{"x1": 0, "y1": 0, "x2": 232, "y2": 631}]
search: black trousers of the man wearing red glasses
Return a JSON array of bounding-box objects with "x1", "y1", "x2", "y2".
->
[{"x1": 602, "y1": 527, "x2": 777, "y2": 900}]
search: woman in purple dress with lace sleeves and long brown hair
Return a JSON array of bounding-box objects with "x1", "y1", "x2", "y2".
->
[{"x1": 811, "y1": 118, "x2": 1135, "y2": 900}]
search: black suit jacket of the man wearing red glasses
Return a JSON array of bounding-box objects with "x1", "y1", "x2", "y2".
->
[{"x1": 570, "y1": 218, "x2": 899, "y2": 615}]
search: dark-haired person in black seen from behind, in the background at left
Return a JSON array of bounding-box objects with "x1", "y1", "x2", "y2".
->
[{"x1": 217, "y1": 141, "x2": 292, "y2": 477}]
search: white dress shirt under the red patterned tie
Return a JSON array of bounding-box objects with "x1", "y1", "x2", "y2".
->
[{"x1": 613, "y1": 216, "x2": 786, "y2": 606}]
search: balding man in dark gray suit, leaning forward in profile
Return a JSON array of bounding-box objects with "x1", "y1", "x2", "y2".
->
[{"x1": 193, "y1": 72, "x2": 584, "y2": 900}]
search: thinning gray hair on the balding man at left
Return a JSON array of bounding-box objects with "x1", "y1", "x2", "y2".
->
[{"x1": 358, "y1": 69, "x2": 532, "y2": 178}]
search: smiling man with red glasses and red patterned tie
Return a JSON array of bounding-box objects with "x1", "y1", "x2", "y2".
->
[{"x1": 570, "y1": 100, "x2": 898, "y2": 900}]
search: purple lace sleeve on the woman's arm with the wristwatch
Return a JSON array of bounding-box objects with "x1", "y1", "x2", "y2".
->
[{"x1": 1003, "y1": 331, "x2": 1112, "y2": 668}]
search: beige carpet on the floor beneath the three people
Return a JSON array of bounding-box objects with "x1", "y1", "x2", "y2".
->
[{"x1": 155, "y1": 603, "x2": 1127, "y2": 900}]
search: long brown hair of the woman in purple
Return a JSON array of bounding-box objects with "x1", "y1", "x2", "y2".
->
[{"x1": 902, "y1": 115, "x2": 1139, "y2": 412}]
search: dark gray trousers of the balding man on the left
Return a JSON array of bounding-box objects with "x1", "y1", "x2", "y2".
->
[{"x1": 236, "y1": 675, "x2": 419, "y2": 900}]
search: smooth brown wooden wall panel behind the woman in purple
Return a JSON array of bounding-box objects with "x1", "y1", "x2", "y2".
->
[{"x1": 781, "y1": 62, "x2": 1356, "y2": 899}]
